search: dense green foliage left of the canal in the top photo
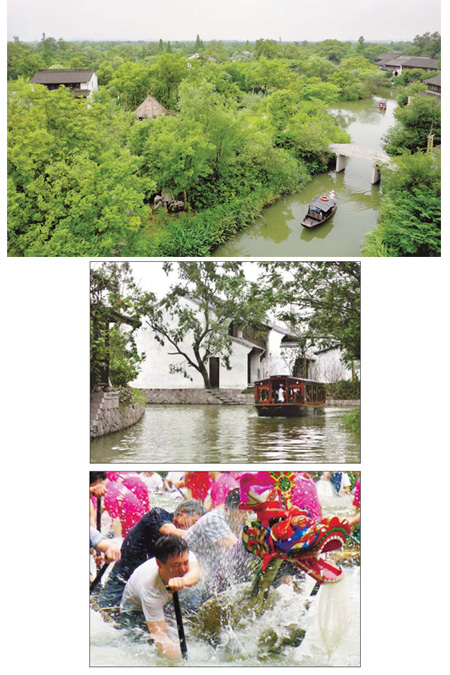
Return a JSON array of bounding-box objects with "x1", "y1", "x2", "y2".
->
[{"x1": 8, "y1": 35, "x2": 440, "y2": 256}]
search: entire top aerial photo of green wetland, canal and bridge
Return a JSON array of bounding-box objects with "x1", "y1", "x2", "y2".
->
[{"x1": 8, "y1": 0, "x2": 441, "y2": 258}]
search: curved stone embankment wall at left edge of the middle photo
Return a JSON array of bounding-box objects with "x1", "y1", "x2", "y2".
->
[{"x1": 91, "y1": 391, "x2": 145, "y2": 438}]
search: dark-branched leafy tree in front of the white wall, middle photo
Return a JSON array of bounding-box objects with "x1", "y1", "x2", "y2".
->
[{"x1": 144, "y1": 262, "x2": 270, "y2": 389}]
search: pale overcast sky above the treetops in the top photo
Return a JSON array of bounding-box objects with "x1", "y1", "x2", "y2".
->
[{"x1": 8, "y1": 0, "x2": 440, "y2": 41}]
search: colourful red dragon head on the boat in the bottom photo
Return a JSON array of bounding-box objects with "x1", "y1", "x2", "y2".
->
[{"x1": 239, "y1": 471, "x2": 350, "y2": 611}]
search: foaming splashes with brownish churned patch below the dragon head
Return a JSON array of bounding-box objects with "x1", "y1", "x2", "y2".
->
[{"x1": 90, "y1": 486, "x2": 360, "y2": 667}]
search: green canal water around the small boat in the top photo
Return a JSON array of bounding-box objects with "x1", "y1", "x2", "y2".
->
[{"x1": 212, "y1": 90, "x2": 397, "y2": 258}]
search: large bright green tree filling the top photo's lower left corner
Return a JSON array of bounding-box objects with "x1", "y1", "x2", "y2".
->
[{"x1": 8, "y1": 81, "x2": 152, "y2": 256}]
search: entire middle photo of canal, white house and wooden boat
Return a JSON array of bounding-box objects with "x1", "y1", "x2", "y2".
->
[{"x1": 90, "y1": 260, "x2": 361, "y2": 463}]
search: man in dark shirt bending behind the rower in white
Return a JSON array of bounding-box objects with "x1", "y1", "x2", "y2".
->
[{"x1": 98, "y1": 500, "x2": 205, "y2": 607}]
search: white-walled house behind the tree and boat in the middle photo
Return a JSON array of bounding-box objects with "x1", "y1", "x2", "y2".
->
[{"x1": 130, "y1": 298, "x2": 351, "y2": 390}]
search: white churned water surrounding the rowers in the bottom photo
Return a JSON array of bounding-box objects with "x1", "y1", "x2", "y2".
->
[{"x1": 90, "y1": 486, "x2": 360, "y2": 667}]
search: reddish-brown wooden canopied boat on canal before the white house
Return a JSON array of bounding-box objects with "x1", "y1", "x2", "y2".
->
[{"x1": 255, "y1": 375, "x2": 325, "y2": 417}]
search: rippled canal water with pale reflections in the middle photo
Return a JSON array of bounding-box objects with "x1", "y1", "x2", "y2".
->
[{"x1": 91, "y1": 405, "x2": 360, "y2": 464}]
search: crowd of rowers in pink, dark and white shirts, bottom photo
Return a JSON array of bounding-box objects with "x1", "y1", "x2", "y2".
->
[{"x1": 90, "y1": 471, "x2": 359, "y2": 658}]
